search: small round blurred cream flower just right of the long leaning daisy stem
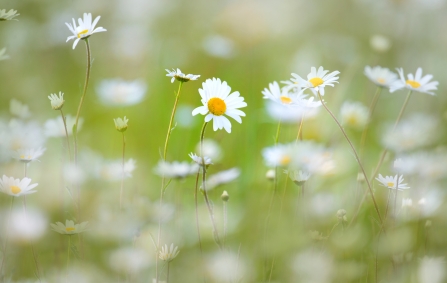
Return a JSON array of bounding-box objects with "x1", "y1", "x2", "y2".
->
[{"x1": 340, "y1": 101, "x2": 369, "y2": 129}]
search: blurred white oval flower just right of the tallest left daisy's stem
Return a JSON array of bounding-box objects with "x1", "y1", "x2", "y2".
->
[{"x1": 96, "y1": 79, "x2": 147, "y2": 106}]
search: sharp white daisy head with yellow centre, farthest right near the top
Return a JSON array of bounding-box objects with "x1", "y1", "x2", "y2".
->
[{"x1": 390, "y1": 68, "x2": 438, "y2": 95}]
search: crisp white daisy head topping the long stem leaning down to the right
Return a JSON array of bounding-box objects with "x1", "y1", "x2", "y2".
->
[{"x1": 290, "y1": 66, "x2": 340, "y2": 96}]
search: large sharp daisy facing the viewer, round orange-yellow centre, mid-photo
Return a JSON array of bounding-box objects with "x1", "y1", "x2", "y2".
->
[{"x1": 192, "y1": 78, "x2": 247, "y2": 133}]
